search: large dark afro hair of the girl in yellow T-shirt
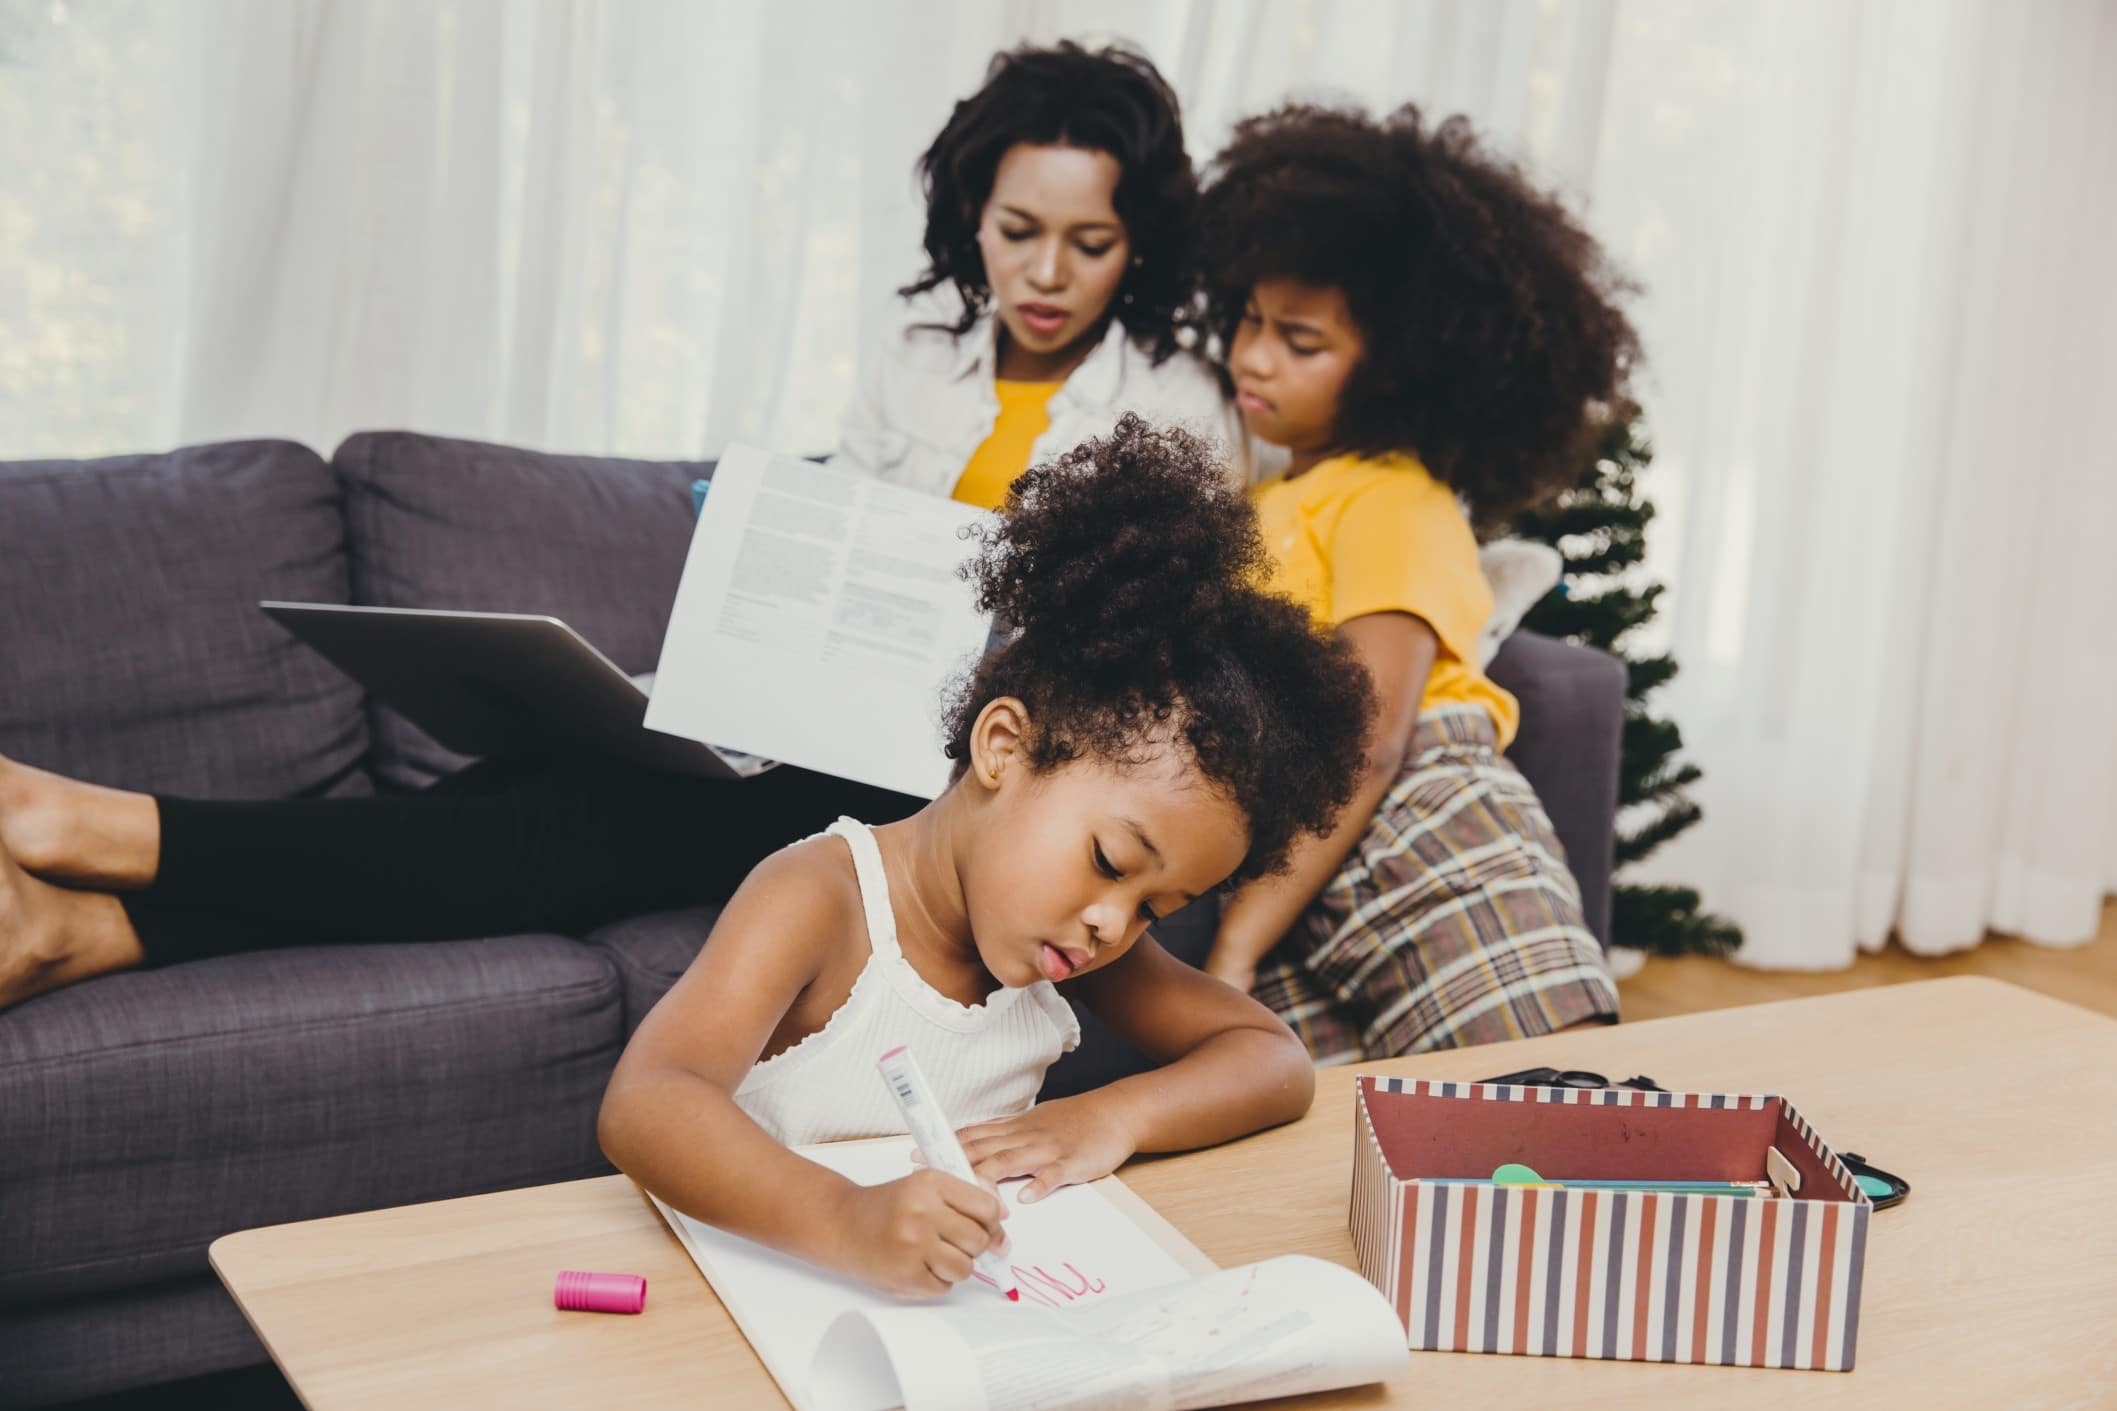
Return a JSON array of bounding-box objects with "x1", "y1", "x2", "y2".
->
[{"x1": 1196, "y1": 104, "x2": 1639, "y2": 523}]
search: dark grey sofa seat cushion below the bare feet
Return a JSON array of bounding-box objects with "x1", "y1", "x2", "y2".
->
[{"x1": 0, "y1": 935, "x2": 622, "y2": 1309}]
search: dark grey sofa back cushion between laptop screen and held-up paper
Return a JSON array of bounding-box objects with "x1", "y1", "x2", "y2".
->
[{"x1": 332, "y1": 432, "x2": 711, "y2": 789}]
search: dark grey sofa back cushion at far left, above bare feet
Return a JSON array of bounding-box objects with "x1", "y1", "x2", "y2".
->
[{"x1": 0, "y1": 440, "x2": 368, "y2": 798}]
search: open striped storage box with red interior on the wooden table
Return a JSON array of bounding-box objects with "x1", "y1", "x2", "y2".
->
[{"x1": 1351, "y1": 1077, "x2": 1874, "y2": 1371}]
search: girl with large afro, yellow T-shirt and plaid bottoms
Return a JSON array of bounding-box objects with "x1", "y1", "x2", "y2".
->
[{"x1": 1200, "y1": 106, "x2": 1636, "y2": 1062}]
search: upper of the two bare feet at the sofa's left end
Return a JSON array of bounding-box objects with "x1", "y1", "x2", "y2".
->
[{"x1": 0, "y1": 755, "x2": 161, "y2": 891}]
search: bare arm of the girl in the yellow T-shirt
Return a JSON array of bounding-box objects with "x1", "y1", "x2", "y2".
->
[{"x1": 1205, "y1": 611, "x2": 1440, "y2": 990}]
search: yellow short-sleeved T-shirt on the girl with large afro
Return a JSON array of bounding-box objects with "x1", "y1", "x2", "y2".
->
[{"x1": 1251, "y1": 455, "x2": 1522, "y2": 749}]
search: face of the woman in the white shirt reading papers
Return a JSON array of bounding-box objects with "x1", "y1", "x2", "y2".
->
[{"x1": 978, "y1": 142, "x2": 1133, "y2": 377}]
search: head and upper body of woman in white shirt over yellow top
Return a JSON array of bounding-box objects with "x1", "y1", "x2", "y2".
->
[{"x1": 832, "y1": 44, "x2": 1249, "y2": 497}]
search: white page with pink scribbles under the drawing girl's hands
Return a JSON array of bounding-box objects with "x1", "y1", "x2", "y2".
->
[{"x1": 663, "y1": 1133, "x2": 1194, "y2": 1409}]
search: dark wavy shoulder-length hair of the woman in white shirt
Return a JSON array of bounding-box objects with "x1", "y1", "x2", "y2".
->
[{"x1": 898, "y1": 40, "x2": 1198, "y2": 362}]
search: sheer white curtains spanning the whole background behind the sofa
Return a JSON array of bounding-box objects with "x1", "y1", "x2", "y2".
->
[{"x1": 0, "y1": 0, "x2": 2117, "y2": 967}]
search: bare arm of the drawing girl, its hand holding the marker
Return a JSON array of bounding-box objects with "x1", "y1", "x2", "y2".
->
[{"x1": 597, "y1": 840, "x2": 1001, "y2": 1295}]
